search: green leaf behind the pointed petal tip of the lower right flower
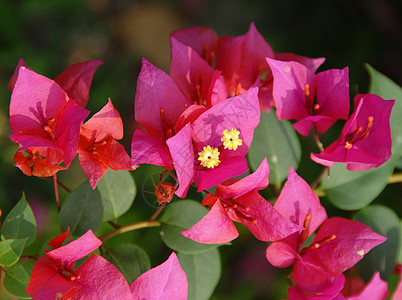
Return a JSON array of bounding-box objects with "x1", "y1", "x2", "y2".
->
[{"x1": 355, "y1": 205, "x2": 401, "y2": 281}]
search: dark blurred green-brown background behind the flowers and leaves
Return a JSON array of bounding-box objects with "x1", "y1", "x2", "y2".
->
[{"x1": 0, "y1": 0, "x2": 402, "y2": 299}]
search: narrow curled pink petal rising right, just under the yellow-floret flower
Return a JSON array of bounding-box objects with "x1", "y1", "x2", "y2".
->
[{"x1": 215, "y1": 158, "x2": 269, "y2": 199}]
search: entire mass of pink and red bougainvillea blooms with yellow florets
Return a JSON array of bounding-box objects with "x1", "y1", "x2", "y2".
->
[{"x1": 3, "y1": 23, "x2": 400, "y2": 299}]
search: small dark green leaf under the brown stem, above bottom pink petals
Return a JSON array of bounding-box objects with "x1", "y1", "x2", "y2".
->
[{"x1": 104, "y1": 244, "x2": 151, "y2": 284}]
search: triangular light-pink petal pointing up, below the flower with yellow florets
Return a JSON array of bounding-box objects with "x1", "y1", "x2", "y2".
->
[{"x1": 181, "y1": 201, "x2": 239, "y2": 244}]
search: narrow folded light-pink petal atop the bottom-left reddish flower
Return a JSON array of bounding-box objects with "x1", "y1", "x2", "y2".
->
[{"x1": 46, "y1": 230, "x2": 102, "y2": 267}]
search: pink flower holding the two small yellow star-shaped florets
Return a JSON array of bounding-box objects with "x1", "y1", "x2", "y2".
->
[{"x1": 166, "y1": 88, "x2": 260, "y2": 197}]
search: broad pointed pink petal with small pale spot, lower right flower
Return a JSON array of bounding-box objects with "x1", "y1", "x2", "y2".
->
[{"x1": 303, "y1": 217, "x2": 386, "y2": 275}]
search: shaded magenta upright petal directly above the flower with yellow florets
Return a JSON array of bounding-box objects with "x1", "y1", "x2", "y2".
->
[{"x1": 170, "y1": 37, "x2": 227, "y2": 108}]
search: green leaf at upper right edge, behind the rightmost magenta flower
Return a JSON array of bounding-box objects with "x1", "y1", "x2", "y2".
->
[{"x1": 366, "y1": 64, "x2": 402, "y2": 156}]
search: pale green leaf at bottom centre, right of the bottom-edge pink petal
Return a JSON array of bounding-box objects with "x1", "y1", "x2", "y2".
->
[{"x1": 178, "y1": 249, "x2": 221, "y2": 300}]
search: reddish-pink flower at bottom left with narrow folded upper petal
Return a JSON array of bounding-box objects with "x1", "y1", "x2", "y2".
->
[{"x1": 26, "y1": 230, "x2": 131, "y2": 300}]
